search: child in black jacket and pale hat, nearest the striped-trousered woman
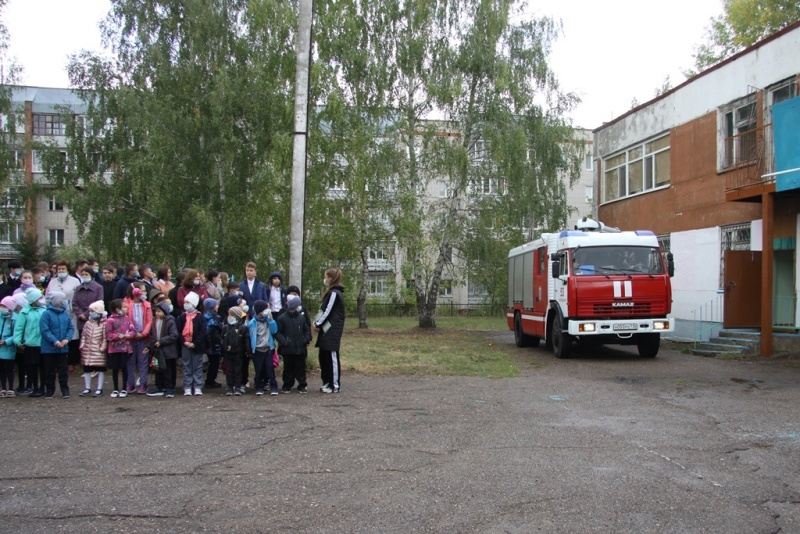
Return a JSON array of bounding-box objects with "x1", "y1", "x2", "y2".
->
[{"x1": 275, "y1": 295, "x2": 311, "y2": 393}]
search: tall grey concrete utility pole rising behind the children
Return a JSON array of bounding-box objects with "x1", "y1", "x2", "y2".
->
[{"x1": 289, "y1": 0, "x2": 314, "y2": 291}]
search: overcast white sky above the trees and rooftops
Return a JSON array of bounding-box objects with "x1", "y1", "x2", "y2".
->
[{"x1": 3, "y1": 0, "x2": 722, "y2": 128}]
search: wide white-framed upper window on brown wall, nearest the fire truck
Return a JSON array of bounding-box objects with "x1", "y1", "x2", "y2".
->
[{"x1": 603, "y1": 134, "x2": 670, "y2": 202}]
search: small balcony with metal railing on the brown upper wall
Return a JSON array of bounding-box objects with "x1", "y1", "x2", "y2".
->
[{"x1": 720, "y1": 124, "x2": 775, "y2": 201}]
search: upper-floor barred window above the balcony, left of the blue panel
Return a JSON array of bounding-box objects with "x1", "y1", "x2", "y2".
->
[{"x1": 721, "y1": 96, "x2": 758, "y2": 169}]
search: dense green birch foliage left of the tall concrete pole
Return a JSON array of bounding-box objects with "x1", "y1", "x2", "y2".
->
[{"x1": 43, "y1": 0, "x2": 295, "y2": 272}]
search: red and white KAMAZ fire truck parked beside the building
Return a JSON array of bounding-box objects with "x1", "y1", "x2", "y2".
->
[{"x1": 506, "y1": 218, "x2": 675, "y2": 358}]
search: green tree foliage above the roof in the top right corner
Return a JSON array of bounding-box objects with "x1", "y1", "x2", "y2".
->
[{"x1": 686, "y1": 0, "x2": 800, "y2": 76}]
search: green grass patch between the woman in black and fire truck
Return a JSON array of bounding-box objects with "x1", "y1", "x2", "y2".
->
[{"x1": 342, "y1": 317, "x2": 519, "y2": 378}]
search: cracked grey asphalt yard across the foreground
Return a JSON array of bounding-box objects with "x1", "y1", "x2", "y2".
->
[{"x1": 0, "y1": 334, "x2": 800, "y2": 533}]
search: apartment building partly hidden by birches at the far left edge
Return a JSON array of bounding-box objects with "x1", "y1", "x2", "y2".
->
[{"x1": 0, "y1": 87, "x2": 86, "y2": 259}]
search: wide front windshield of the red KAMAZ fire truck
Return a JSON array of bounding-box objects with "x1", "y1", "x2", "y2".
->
[{"x1": 571, "y1": 246, "x2": 664, "y2": 275}]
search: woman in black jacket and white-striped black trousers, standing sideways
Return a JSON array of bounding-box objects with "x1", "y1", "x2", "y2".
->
[{"x1": 314, "y1": 269, "x2": 345, "y2": 393}]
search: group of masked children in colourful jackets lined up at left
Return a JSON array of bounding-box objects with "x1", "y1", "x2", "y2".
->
[{"x1": 0, "y1": 270, "x2": 322, "y2": 398}]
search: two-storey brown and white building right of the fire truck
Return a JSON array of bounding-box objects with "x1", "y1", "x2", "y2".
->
[{"x1": 594, "y1": 23, "x2": 800, "y2": 353}]
